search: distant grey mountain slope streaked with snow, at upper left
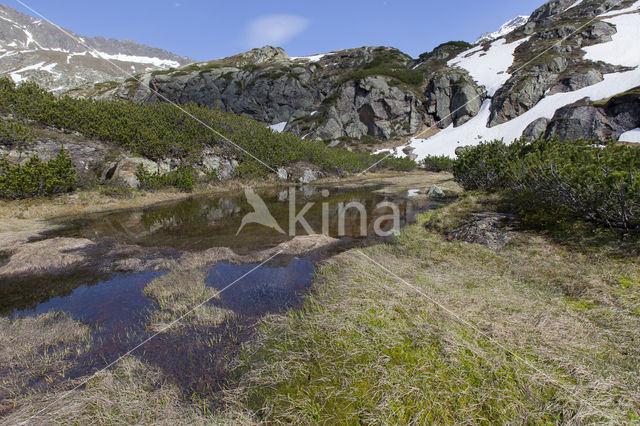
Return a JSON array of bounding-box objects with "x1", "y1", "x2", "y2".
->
[{"x1": 0, "y1": 5, "x2": 193, "y2": 92}]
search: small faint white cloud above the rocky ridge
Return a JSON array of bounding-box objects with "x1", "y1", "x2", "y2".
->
[{"x1": 246, "y1": 15, "x2": 309, "y2": 48}]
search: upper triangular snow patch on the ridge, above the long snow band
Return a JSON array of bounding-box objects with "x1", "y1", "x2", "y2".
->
[{"x1": 447, "y1": 37, "x2": 529, "y2": 96}]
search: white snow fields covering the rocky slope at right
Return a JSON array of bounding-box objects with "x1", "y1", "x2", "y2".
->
[{"x1": 379, "y1": 7, "x2": 640, "y2": 160}]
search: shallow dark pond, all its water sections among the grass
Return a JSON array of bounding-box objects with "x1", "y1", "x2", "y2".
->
[{"x1": 0, "y1": 187, "x2": 439, "y2": 400}]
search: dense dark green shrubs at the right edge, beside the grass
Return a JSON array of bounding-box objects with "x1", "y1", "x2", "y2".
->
[{"x1": 454, "y1": 140, "x2": 640, "y2": 231}]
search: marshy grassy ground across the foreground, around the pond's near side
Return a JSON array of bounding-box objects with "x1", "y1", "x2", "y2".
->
[{"x1": 0, "y1": 173, "x2": 640, "y2": 424}]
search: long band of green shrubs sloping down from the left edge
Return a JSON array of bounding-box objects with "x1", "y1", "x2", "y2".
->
[{"x1": 0, "y1": 79, "x2": 414, "y2": 185}]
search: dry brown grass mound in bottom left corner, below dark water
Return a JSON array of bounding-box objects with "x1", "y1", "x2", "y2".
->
[{"x1": 2, "y1": 357, "x2": 252, "y2": 425}]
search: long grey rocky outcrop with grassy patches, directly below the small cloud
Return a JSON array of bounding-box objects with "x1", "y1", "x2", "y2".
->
[{"x1": 94, "y1": 46, "x2": 426, "y2": 140}]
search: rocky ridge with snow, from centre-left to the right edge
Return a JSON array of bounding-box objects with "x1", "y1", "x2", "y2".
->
[{"x1": 1, "y1": 0, "x2": 640, "y2": 158}]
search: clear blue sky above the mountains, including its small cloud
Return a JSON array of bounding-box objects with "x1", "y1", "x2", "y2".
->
[{"x1": 11, "y1": 0, "x2": 545, "y2": 61}]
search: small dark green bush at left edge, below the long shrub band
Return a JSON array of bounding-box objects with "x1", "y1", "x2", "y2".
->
[{"x1": 0, "y1": 149, "x2": 76, "y2": 199}]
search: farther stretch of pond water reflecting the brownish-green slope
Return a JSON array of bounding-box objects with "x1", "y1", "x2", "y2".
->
[{"x1": 52, "y1": 186, "x2": 437, "y2": 253}]
